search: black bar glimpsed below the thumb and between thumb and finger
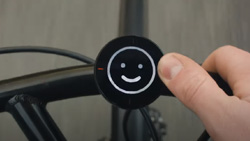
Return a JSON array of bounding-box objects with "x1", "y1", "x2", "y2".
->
[{"x1": 161, "y1": 72, "x2": 233, "y2": 97}]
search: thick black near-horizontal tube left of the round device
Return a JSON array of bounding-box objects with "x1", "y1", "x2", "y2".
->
[{"x1": 0, "y1": 65, "x2": 98, "y2": 112}]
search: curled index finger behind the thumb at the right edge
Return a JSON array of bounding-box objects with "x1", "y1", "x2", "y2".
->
[{"x1": 202, "y1": 46, "x2": 250, "y2": 102}]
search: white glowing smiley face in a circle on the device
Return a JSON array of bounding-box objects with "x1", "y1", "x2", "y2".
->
[{"x1": 107, "y1": 46, "x2": 156, "y2": 94}]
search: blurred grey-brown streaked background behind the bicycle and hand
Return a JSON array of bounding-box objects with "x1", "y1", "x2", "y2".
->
[{"x1": 0, "y1": 0, "x2": 250, "y2": 141}]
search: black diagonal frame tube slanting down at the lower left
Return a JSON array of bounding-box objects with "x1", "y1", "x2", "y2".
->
[{"x1": 6, "y1": 95, "x2": 66, "y2": 141}]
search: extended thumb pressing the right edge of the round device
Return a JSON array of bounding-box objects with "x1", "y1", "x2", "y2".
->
[{"x1": 158, "y1": 53, "x2": 228, "y2": 119}]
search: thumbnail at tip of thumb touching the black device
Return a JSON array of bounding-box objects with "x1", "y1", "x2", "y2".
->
[{"x1": 158, "y1": 55, "x2": 183, "y2": 82}]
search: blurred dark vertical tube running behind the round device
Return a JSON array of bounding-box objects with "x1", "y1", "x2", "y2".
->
[{"x1": 111, "y1": 0, "x2": 150, "y2": 141}]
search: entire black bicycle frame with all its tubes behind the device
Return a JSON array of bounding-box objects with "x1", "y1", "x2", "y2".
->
[{"x1": 0, "y1": 0, "x2": 232, "y2": 141}]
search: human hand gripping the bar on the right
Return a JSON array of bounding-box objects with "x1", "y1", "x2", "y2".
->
[{"x1": 158, "y1": 46, "x2": 250, "y2": 141}]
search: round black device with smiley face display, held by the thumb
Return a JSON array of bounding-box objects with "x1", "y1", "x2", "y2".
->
[{"x1": 95, "y1": 36, "x2": 163, "y2": 109}]
